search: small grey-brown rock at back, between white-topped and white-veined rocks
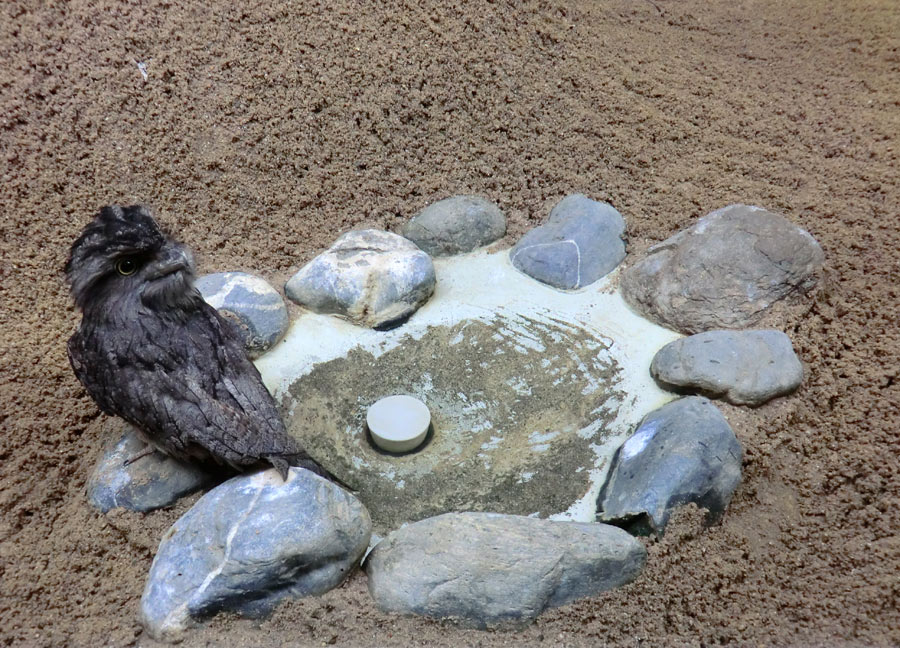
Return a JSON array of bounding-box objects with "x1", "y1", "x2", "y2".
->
[{"x1": 403, "y1": 196, "x2": 506, "y2": 257}]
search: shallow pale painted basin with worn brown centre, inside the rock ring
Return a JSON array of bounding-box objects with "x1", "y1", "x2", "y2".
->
[{"x1": 258, "y1": 251, "x2": 678, "y2": 533}]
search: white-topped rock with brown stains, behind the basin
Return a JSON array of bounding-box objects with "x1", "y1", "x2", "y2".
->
[{"x1": 285, "y1": 229, "x2": 435, "y2": 328}]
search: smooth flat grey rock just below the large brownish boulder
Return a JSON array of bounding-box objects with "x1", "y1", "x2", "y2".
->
[{"x1": 650, "y1": 330, "x2": 803, "y2": 405}]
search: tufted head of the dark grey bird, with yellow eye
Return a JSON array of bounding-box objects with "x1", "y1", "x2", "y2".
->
[{"x1": 65, "y1": 205, "x2": 201, "y2": 311}]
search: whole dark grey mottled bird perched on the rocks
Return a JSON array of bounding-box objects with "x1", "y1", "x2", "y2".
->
[{"x1": 66, "y1": 205, "x2": 327, "y2": 477}]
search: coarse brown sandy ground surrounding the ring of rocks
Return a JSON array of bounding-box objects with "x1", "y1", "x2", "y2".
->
[{"x1": 0, "y1": 0, "x2": 900, "y2": 647}]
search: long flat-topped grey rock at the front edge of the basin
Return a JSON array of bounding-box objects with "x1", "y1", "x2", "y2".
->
[{"x1": 365, "y1": 513, "x2": 646, "y2": 628}]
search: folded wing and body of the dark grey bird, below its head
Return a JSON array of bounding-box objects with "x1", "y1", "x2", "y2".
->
[{"x1": 69, "y1": 304, "x2": 303, "y2": 469}]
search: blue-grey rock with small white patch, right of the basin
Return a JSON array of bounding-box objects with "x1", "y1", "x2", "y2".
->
[{"x1": 598, "y1": 396, "x2": 741, "y2": 536}]
